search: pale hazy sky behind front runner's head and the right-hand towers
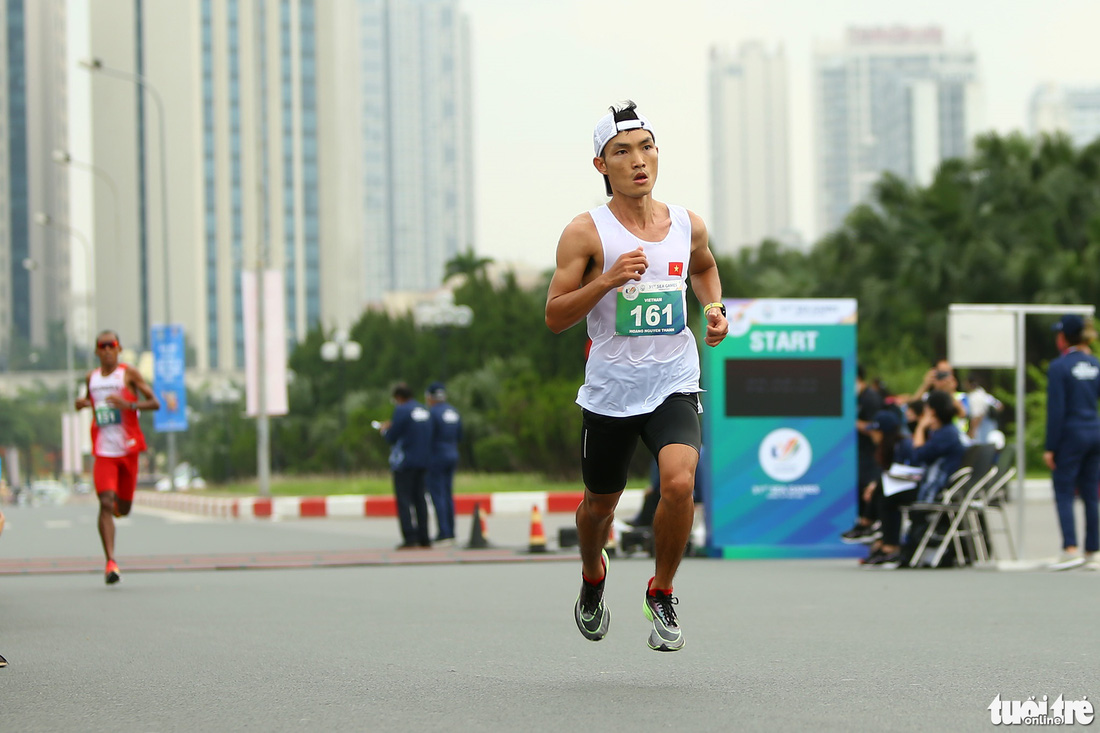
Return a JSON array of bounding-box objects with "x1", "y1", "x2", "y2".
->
[{"x1": 463, "y1": 0, "x2": 1100, "y2": 269}]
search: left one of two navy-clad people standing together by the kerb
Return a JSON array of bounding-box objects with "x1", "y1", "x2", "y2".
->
[{"x1": 378, "y1": 382, "x2": 431, "y2": 549}]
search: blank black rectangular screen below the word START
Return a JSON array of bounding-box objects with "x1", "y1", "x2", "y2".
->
[{"x1": 726, "y1": 359, "x2": 844, "y2": 417}]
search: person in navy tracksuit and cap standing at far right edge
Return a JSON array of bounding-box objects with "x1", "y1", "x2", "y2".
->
[{"x1": 1043, "y1": 314, "x2": 1100, "y2": 570}]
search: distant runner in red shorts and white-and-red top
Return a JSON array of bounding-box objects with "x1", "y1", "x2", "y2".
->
[{"x1": 76, "y1": 331, "x2": 161, "y2": 586}]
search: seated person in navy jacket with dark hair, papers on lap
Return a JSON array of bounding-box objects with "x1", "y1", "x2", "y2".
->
[{"x1": 867, "y1": 390, "x2": 966, "y2": 568}]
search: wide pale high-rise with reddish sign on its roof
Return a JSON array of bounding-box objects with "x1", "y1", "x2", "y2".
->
[{"x1": 814, "y1": 26, "x2": 982, "y2": 232}]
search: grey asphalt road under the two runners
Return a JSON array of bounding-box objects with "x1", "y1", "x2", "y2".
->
[{"x1": 0, "y1": 493, "x2": 1100, "y2": 733}]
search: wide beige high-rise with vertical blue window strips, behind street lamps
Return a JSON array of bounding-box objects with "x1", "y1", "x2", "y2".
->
[{"x1": 80, "y1": 0, "x2": 327, "y2": 372}]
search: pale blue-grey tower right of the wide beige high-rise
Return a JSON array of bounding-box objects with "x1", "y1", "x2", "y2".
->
[{"x1": 349, "y1": 0, "x2": 475, "y2": 304}]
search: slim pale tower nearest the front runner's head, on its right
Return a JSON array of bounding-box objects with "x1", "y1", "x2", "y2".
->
[{"x1": 710, "y1": 43, "x2": 791, "y2": 254}]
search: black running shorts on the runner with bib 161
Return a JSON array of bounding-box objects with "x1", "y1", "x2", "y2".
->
[{"x1": 581, "y1": 393, "x2": 703, "y2": 494}]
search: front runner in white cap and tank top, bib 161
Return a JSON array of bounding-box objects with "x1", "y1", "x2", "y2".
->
[{"x1": 546, "y1": 102, "x2": 728, "y2": 652}]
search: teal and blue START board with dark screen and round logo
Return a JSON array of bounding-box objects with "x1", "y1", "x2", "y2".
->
[{"x1": 703, "y1": 298, "x2": 866, "y2": 558}]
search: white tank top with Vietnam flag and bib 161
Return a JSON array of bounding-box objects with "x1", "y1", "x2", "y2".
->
[{"x1": 576, "y1": 205, "x2": 701, "y2": 417}]
